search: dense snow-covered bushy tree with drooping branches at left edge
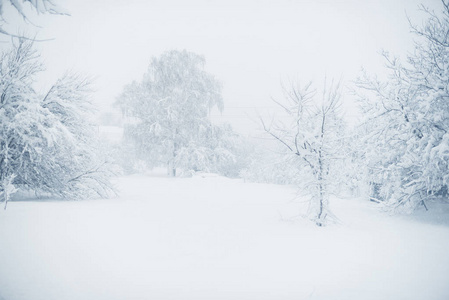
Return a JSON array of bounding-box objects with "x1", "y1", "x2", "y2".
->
[{"x1": 0, "y1": 40, "x2": 111, "y2": 209}]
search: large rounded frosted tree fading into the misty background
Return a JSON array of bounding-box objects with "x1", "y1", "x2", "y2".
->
[{"x1": 117, "y1": 50, "x2": 223, "y2": 176}]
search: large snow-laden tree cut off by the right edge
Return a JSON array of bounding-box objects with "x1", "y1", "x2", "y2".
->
[{"x1": 358, "y1": 0, "x2": 449, "y2": 212}]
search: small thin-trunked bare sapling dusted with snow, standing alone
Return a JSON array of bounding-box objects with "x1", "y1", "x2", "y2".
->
[{"x1": 262, "y1": 79, "x2": 343, "y2": 226}]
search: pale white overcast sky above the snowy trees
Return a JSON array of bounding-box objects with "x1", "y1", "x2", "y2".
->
[{"x1": 0, "y1": 0, "x2": 439, "y2": 133}]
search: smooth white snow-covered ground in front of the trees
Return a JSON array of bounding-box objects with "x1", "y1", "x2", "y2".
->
[{"x1": 0, "y1": 175, "x2": 449, "y2": 300}]
